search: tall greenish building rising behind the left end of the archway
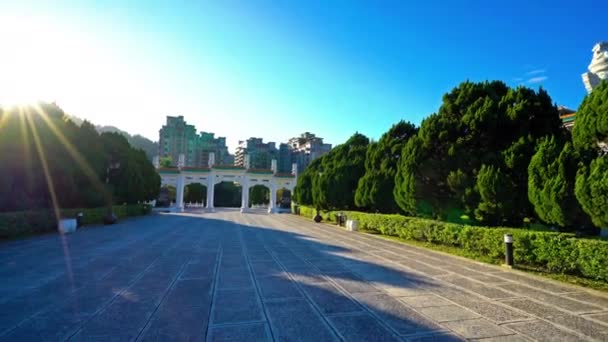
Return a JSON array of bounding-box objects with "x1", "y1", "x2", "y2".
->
[{"x1": 158, "y1": 116, "x2": 233, "y2": 167}]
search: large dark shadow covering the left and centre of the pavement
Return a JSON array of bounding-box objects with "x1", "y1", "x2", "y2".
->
[{"x1": 0, "y1": 213, "x2": 460, "y2": 341}]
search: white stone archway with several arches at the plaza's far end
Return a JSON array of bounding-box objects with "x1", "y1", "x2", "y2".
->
[{"x1": 157, "y1": 156, "x2": 297, "y2": 213}]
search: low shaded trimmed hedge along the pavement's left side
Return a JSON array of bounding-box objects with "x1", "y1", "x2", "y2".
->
[{"x1": 0, "y1": 204, "x2": 152, "y2": 239}]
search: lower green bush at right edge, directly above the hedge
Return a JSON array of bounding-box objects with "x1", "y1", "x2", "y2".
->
[{"x1": 575, "y1": 156, "x2": 608, "y2": 227}]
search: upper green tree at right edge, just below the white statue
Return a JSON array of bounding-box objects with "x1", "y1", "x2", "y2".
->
[{"x1": 572, "y1": 81, "x2": 608, "y2": 150}]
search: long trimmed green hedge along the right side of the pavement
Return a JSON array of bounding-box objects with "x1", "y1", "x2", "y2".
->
[{"x1": 300, "y1": 206, "x2": 608, "y2": 281}]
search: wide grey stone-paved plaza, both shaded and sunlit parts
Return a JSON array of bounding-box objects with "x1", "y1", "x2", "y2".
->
[{"x1": 0, "y1": 210, "x2": 608, "y2": 342}]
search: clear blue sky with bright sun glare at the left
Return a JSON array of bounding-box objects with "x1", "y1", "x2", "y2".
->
[{"x1": 0, "y1": 0, "x2": 608, "y2": 152}]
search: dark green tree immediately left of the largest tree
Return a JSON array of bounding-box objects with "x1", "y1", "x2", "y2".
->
[{"x1": 355, "y1": 121, "x2": 417, "y2": 213}]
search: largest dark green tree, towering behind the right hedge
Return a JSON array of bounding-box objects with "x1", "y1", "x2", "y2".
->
[{"x1": 394, "y1": 81, "x2": 562, "y2": 224}]
